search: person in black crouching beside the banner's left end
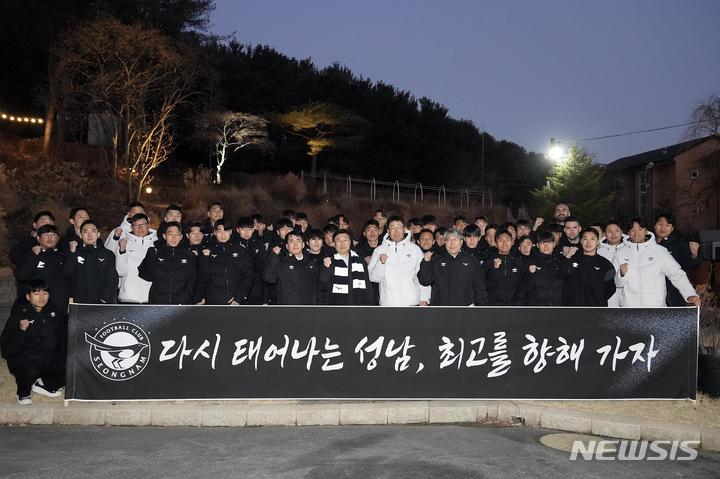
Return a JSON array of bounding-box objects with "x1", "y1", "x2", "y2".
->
[{"x1": 0, "y1": 279, "x2": 65, "y2": 406}]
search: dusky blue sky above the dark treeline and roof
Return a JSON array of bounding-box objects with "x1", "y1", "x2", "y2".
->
[{"x1": 211, "y1": 0, "x2": 720, "y2": 163}]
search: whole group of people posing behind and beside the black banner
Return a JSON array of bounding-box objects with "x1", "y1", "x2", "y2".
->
[{"x1": 0, "y1": 202, "x2": 701, "y2": 404}]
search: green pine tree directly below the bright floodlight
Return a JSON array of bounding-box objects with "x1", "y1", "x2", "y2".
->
[{"x1": 532, "y1": 145, "x2": 614, "y2": 224}]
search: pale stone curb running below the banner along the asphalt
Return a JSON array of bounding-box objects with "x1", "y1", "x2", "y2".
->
[{"x1": 0, "y1": 401, "x2": 720, "y2": 452}]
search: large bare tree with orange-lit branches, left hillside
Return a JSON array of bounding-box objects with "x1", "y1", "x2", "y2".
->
[{"x1": 54, "y1": 20, "x2": 198, "y2": 200}]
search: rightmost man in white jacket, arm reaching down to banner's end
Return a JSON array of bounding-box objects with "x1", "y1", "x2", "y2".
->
[{"x1": 613, "y1": 218, "x2": 700, "y2": 308}]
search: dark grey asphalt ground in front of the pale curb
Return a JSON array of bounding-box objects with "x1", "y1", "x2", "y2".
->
[{"x1": 0, "y1": 426, "x2": 720, "y2": 479}]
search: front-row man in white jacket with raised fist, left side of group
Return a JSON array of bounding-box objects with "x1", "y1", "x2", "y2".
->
[{"x1": 115, "y1": 213, "x2": 157, "y2": 303}]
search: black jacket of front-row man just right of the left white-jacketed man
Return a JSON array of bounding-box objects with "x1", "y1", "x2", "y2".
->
[{"x1": 138, "y1": 244, "x2": 198, "y2": 304}]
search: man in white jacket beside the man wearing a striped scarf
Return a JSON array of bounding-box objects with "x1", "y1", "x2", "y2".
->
[{"x1": 368, "y1": 216, "x2": 430, "y2": 306}]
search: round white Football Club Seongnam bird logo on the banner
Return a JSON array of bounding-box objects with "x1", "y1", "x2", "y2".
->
[{"x1": 85, "y1": 321, "x2": 150, "y2": 381}]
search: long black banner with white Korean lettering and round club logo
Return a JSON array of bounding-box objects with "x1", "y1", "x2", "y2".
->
[{"x1": 65, "y1": 305, "x2": 698, "y2": 400}]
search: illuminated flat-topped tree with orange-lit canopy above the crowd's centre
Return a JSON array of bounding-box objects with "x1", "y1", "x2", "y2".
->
[{"x1": 273, "y1": 103, "x2": 369, "y2": 175}]
